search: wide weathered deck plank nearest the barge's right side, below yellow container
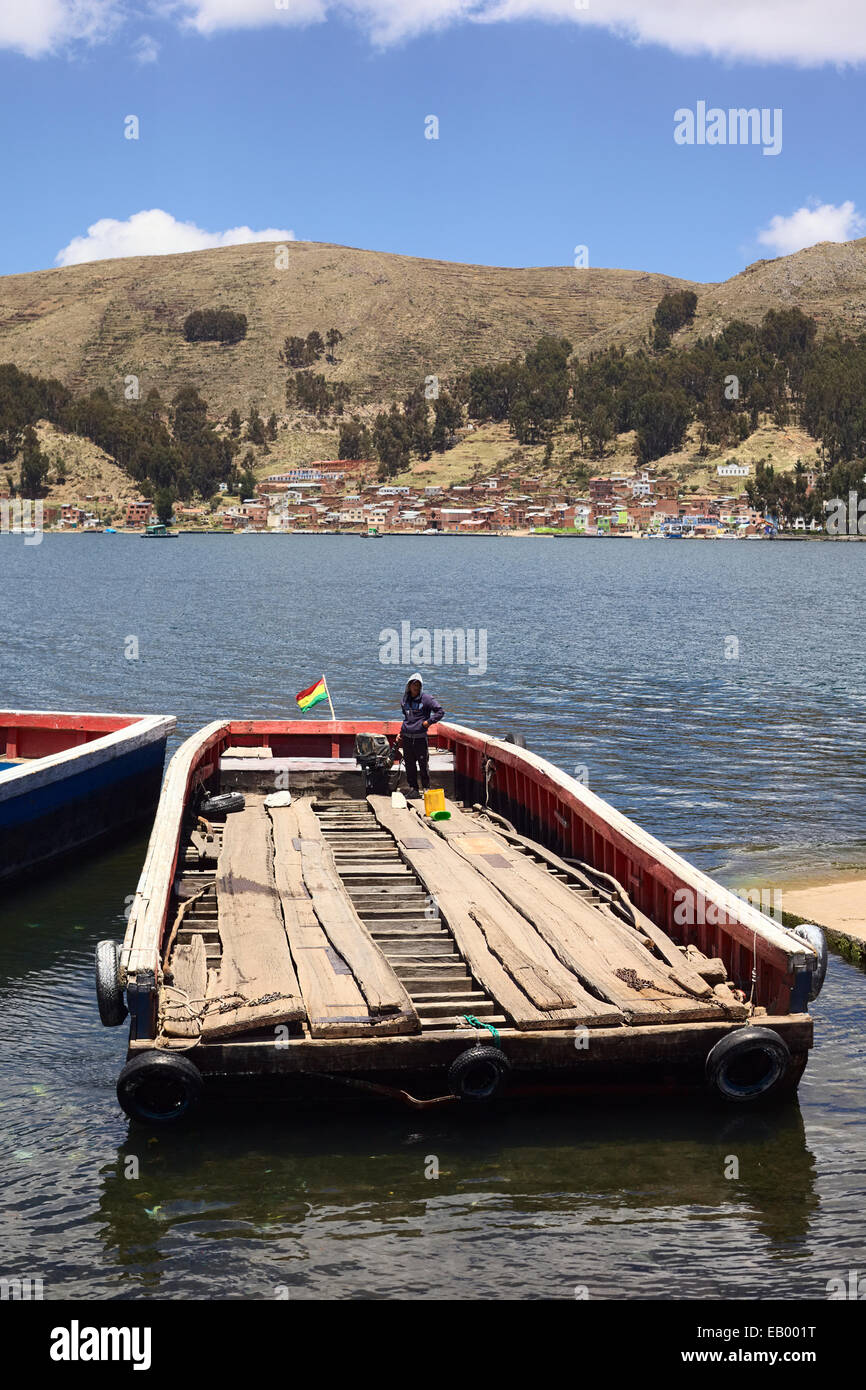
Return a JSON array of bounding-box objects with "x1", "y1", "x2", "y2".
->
[{"x1": 431, "y1": 803, "x2": 720, "y2": 1023}]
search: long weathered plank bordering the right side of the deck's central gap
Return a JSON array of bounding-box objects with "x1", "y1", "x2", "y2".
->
[{"x1": 368, "y1": 796, "x2": 621, "y2": 1029}]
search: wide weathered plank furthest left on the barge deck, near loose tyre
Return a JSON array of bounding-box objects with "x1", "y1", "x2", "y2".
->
[{"x1": 202, "y1": 799, "x2": 304, "y2": 1041}]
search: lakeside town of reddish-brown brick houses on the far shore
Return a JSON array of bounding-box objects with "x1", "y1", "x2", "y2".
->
[{"x1": 13, "y1": 459, "x2": 823, "y2": 539}]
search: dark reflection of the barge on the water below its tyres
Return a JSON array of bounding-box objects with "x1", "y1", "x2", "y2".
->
[{"x1": 88, "y1": 1104, "x2": 819, "y2": 1298}]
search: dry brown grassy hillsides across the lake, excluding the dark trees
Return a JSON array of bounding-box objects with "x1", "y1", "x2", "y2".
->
[{"x1": 0, "y1": 238, "x2": 866, "y2": 503}]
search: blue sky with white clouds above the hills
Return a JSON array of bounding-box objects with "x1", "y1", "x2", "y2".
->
[{"x1": 0, "y1": 0, "x2": 866, "y2": 281}]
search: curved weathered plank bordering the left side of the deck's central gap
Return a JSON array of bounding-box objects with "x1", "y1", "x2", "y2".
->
[{"x1": 292, "y1": 799, "x2": 421, "y2": 1033}]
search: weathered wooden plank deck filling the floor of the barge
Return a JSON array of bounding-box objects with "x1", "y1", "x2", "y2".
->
[{"x1": 161, "y1": 795, "x2": 748, "y2": 1045}]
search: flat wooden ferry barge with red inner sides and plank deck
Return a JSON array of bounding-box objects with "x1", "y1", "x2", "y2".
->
[{"x1": 104, "y1": 720, "x2": 826, "y2": 1122}]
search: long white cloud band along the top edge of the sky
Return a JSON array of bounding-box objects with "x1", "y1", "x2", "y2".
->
[{"x1": 0, "y1": 0, "x2": 866, "y2": 67}]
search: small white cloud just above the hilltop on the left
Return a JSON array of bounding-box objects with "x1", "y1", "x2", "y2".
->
[{"x1": 54, "y1": 207, "x2": 295, "y2": 265}]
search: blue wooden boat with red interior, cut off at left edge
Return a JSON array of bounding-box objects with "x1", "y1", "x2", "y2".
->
[{"x1": 0, "y1": 710, "x2": 175, "y2": 883}]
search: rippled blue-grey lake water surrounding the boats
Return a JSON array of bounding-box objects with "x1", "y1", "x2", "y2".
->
[{"x1": 0, "y1": 535, "x2": 866, "y2": 1298}]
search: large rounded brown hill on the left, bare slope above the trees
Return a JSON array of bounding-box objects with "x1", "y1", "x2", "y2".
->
[{"x1": 0, "y1": 242, "x2": 699, "y2": 416}]
